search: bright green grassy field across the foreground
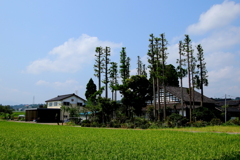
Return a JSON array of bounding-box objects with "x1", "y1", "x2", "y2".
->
[{"x1": 0, "y1": 121, "x2": 240, "y2": 160}]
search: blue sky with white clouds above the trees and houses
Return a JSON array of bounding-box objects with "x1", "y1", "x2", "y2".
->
[{"x1": 0, "y1": 0, "x2": 240, "y2": 105}]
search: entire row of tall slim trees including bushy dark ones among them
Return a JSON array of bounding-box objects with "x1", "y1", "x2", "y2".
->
[{"x1": 86, "y1": 34, "x2": 208, "y2": 124}]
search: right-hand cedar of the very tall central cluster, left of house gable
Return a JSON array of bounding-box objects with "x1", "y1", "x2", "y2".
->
[{"x1": 160, "y1": 33, "x2": 168, "y2": 121}]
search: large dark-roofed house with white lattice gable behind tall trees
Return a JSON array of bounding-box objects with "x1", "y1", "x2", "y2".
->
[{"x1": 147, "y1": 86, "x2": 215, "y2": 117}]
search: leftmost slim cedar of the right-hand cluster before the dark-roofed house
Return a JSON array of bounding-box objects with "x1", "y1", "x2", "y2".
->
[{"x1": 177, "y1": 41, "x2": 187, "y2": 116}]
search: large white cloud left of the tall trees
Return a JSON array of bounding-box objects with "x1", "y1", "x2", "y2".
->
[{"x1": 27, "y1": 34, "x2": 122, "y2": 74}]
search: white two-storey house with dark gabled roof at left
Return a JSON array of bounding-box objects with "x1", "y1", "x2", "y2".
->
[{"x1": 45, "y1": 93, "x2": 86, "y2": 121}]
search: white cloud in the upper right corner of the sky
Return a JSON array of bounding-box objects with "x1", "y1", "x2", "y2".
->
[{"x1": 187, "y1": 1, "x2": 240, "y2": 34}]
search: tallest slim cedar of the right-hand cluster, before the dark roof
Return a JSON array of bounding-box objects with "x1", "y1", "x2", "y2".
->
[{"x1": 184, "y1": 35, "x2": 192, "y2": 122}]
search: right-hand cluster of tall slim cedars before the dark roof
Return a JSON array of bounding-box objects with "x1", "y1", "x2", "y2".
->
[{"x1": 177, "y1": 35, "x2": 208, "y2": 122}]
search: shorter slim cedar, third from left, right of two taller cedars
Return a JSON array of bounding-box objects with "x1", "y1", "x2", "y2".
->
[{"x1": 109, "y1": 62, "x2": 118, "y2": 101}]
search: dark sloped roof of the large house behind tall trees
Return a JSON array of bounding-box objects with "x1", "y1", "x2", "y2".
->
[{"x1": 166, "y1": 86, "x2": 215, "y2": 103}]
